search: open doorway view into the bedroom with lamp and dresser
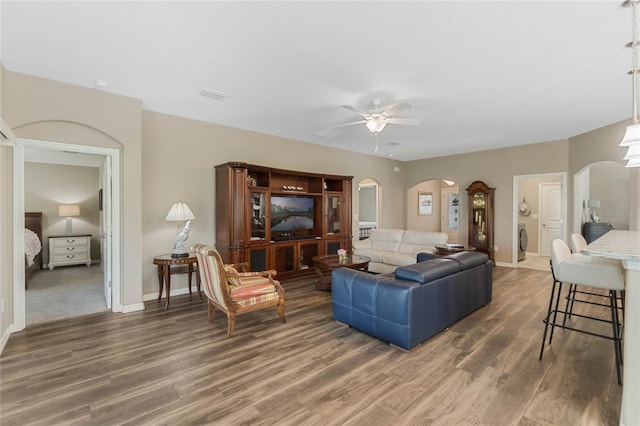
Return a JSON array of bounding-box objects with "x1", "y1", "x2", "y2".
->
[{"x1": 24, "y1": 155, "x2": 108, "y2": 326}]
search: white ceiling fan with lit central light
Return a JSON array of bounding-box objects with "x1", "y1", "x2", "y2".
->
[{"x1": 316, "y1": 99, "x2": 422, "y2": 138}]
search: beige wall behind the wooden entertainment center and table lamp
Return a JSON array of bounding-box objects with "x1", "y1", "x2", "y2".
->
[{"x1": 142, "y1": 111, "x2": 405, "y2": 295}]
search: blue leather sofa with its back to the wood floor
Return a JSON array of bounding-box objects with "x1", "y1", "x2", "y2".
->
[{"x1": 331, "y1": 251, "x2": 493, "y2": 350}]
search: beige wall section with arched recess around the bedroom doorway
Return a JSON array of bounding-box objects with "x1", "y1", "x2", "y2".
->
[{"x1": 2, "y1": 71, "x2": 142, "y2": 309}]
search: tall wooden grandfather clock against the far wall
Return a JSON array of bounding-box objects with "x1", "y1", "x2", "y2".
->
[{"x1": 467, "y1": 180, "x2": 495, "y2": 261}]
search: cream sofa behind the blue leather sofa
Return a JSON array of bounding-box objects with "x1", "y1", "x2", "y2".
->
[{"x1": 353, "y1": 229, "x2": 448, "y2": 274}]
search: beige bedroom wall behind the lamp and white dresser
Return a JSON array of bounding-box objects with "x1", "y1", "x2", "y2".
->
[{"x1": 24, "y1": 163, "x2": 100, "y2": 266}]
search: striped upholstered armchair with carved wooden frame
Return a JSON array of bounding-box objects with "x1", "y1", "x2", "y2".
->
[{"x1": 191, "y1": 244, "x2": 286, "y2": 337}]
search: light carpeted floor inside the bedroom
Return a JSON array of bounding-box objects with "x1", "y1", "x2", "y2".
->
[{"x1": 25, "y1": 265, "x2": 107, "y2": 325}]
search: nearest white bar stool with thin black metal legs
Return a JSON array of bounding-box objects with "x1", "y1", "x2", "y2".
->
[{"x1": 539, "y1": 239, "x2": 625, "y2": 385}]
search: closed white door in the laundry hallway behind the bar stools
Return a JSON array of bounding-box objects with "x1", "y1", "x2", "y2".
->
[{"x1": 538, "y1": 183, "x2": 562, "y2": 256}]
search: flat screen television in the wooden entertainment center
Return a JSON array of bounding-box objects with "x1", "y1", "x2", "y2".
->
[{"x1": 271, "y1": 196, "x2": 314, "y2": 233}]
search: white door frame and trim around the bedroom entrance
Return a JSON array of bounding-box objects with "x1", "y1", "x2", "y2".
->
[{"x1": 13, "y1": 140, "x2": 122, "y2": 331}]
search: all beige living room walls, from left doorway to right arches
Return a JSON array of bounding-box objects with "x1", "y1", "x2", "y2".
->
[{"x1": 0, "y1": 71, "x2": 640, "y2": 334}]
